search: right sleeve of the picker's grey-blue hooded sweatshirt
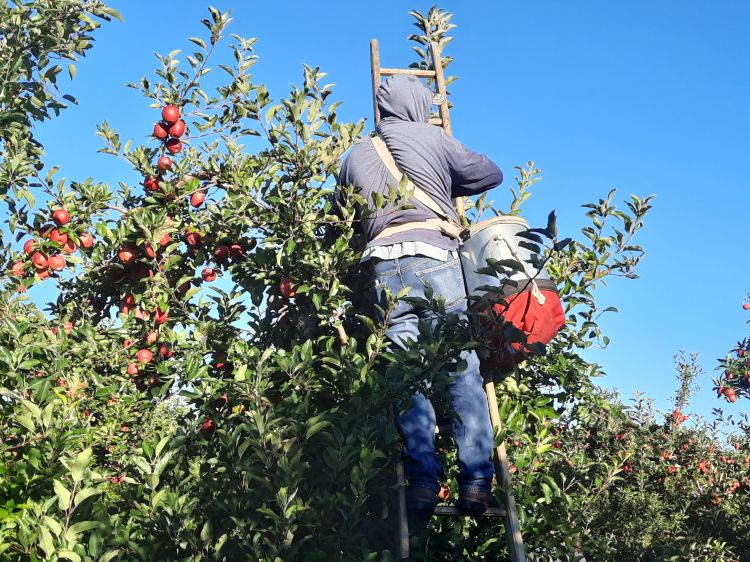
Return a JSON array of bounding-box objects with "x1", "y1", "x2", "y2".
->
[{"x1": 441, "y1": 131, "x2": 503, "y2": 197}]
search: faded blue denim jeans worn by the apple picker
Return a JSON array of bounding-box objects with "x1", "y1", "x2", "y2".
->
[{"x1": 367, "y1": 255, "x2": 493, "y2": 492}]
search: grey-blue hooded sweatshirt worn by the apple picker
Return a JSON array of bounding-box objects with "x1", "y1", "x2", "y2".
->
[{"x1": 338, "y1": 75, "x2": 503, "y2": 250}]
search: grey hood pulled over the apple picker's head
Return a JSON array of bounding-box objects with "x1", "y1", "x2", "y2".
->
[{"x1": 376, "y1": 74, "x2": 432, "y2": 123}]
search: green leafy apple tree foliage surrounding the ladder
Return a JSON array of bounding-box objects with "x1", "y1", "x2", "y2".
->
[{"x1": 0, "y1": 4, "x2": 750, "y2": 562}]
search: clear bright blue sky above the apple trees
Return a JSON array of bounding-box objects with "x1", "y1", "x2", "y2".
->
[{"x1": 32, "y1": 0, "x2": 750, "y2": 420}]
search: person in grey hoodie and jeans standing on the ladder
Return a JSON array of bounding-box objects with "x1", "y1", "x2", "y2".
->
[{"x1": 338, "y1": 75, "x2": 503, "y2": 515}]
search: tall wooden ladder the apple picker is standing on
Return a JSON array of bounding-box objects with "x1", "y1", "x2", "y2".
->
[{"x1": 370, "y1": 39, "x2": 526, "y2": 562}]
